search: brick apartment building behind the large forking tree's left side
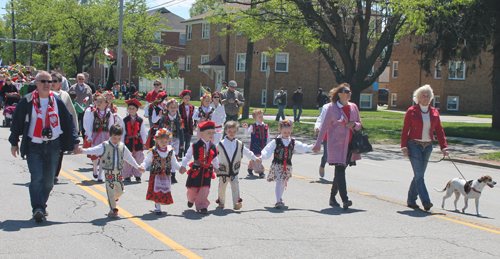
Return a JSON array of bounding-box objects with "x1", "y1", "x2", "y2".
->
[{"x1": 182, "y1": 7, "x2": 377, "y2": 109}]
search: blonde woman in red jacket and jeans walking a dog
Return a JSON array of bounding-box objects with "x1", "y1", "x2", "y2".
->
[{"x1": 401, "y1": 85, "x2": 449, "y2": 211}]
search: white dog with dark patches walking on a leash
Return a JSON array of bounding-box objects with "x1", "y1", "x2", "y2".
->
[{"x1": 434, "y1": 175, "x2": 497, "y2": 216}]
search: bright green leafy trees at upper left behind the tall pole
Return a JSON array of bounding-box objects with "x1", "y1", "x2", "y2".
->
[{"x1": 14, "y1": 0, "x2": 164, "y2": 74}]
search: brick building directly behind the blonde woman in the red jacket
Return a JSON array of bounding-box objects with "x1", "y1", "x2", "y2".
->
[{"x1": 386, "y1": 37, "x2": 493, "y2": 113}]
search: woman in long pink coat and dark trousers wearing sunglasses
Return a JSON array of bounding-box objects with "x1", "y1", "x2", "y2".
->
[{"x1": 313, "y1": 83, "x2": 362, "y2": 210}]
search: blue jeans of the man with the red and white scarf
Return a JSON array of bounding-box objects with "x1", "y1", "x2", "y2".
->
[{"x1": 26, "y1": 139, "x2": 61, "y2": 212}]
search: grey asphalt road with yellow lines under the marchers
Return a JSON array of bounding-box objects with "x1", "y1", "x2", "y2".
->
[{"x1": 0, "y1": 110, "x2": 500, "y2": 258}]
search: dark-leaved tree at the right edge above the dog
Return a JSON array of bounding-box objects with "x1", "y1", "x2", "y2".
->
[{"x1": 417, "y1": 0, "x2": 500, "y2": 129}]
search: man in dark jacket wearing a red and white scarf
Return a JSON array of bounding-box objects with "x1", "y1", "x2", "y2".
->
[{"x1": 9, "y1": 71, "x2": 80, "y2": 222}]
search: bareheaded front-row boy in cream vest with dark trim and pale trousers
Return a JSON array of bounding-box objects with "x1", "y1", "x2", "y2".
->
[{"x1": 216, "y1": 121, "x2": 261, "y2": 210}]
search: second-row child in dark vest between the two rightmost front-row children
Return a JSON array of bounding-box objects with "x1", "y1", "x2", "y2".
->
[{"x1": 242, "y1": 109, "x2": 271, "y2": 178}]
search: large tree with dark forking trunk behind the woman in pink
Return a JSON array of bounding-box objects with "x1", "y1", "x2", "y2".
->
[{"x1": 208, "y1": 0, "x2": 471, "y2": 104}]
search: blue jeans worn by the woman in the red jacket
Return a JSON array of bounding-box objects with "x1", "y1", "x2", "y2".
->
[{"x1": 407, "y1": 141, "x2": 432, "y2": 206}]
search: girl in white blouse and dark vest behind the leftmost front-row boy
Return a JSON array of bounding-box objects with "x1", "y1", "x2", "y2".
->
[{"x1": 83, "y1": 92, "x2": 120, "y2": 182}]
